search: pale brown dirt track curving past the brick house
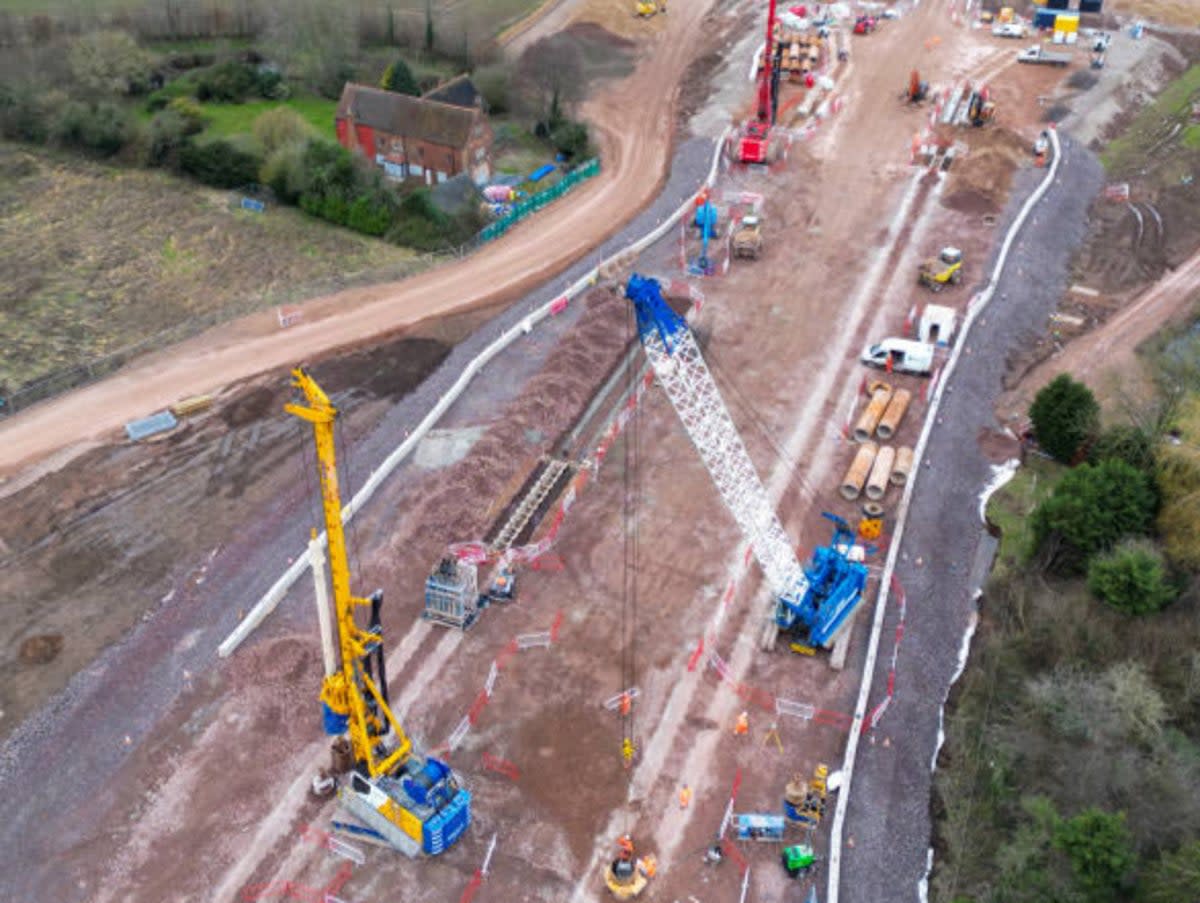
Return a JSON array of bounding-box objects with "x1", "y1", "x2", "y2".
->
[{"x1": 0, "y1": 0, "x2": 715, "y2": 487}]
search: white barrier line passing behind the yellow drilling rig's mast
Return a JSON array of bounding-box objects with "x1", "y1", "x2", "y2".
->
[{"x1": 217, "y1": 126, "x2": 732, "y2": 658}]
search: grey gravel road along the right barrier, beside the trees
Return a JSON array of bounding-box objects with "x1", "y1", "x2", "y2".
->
[{"x1": 842, "y1": 136, "x2": 1103, "y2": 903}]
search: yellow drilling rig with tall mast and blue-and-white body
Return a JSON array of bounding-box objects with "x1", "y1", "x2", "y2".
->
[{"x1": 286, "y1": 370, "x2": 470, "y2": 856}]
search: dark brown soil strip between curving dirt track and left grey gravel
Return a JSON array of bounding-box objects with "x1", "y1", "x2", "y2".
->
[{"x1": 0, "y1": 323, "x2": 469, "y2": 736}]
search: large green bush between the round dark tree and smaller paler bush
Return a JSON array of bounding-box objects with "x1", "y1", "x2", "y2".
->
[{"x1": 1032, "y1": 459, "x2": 1158, "y2": 570}]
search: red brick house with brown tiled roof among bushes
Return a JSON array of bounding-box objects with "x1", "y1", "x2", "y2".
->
[{"x1": 334, "y1": 79, "x2": 492, "y2": 185}]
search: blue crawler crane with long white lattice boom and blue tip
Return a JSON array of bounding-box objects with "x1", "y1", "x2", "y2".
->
[{"x1": 625, "y1": 273, "x2": 868, "y2": 652}]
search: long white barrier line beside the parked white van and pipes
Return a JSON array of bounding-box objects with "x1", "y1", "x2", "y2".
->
[{"x1": 826, "y1": 128, "x2": 1062, "y2": 903}]
